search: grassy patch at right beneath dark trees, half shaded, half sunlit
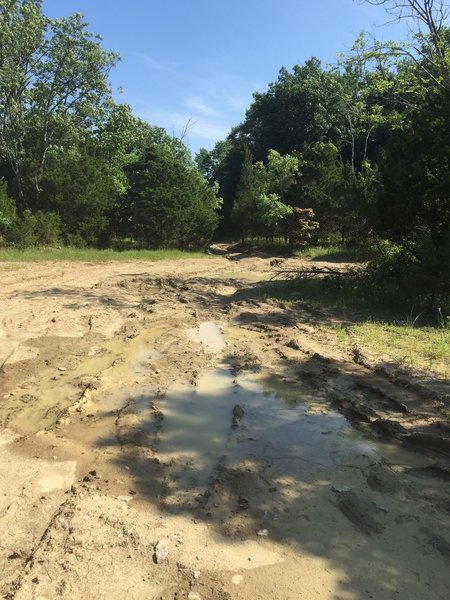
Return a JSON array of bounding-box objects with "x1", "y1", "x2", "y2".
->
[{"x1": 267, "y1": 273, "x2": 450, "y2": 378}]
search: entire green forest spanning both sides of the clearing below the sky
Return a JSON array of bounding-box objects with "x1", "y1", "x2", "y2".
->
[{"x1": 0, "y1": 0, "x2": 450, "y2": 305}]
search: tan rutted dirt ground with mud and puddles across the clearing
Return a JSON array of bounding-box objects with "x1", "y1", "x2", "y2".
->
[{"x1": 0, "y1": 247, "x2": 450, "y2": 600}]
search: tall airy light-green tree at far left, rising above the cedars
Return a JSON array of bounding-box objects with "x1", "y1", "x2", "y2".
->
[{"x1": 0, "y1": 0, "x2": 117, "y2": 210}]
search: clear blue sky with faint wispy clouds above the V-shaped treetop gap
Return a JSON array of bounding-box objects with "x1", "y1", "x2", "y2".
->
[{"x1": 44, "y1": 0, "x2": 406, "y2": 153}]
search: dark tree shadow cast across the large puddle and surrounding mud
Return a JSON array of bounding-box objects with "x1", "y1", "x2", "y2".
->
[{"x1": 88, "y1": 279, "x2": 450, "y2": 600}]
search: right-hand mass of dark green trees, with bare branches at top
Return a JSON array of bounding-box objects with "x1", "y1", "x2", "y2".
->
[{"x1": 196, "y1": 0, "x2": 450, "y2": 312}]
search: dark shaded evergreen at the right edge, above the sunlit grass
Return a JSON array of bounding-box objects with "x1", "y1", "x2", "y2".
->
[{"x1": 378, "y1": 89, "x2": 450, "y2": 301}]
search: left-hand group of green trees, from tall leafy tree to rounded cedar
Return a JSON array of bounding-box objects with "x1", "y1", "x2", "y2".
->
[{"x1": 0, "y1": 0, "x2": 220, "y2": 248}]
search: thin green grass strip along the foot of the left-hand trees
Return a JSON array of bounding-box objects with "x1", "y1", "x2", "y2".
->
[{"x1": 0, "y1": 247, "x2": 209, "y2": 262}]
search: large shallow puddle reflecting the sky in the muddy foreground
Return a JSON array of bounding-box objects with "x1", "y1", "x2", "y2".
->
[{"x1": 158, "y1": 364, "x2": 361, "y2": 485}]
